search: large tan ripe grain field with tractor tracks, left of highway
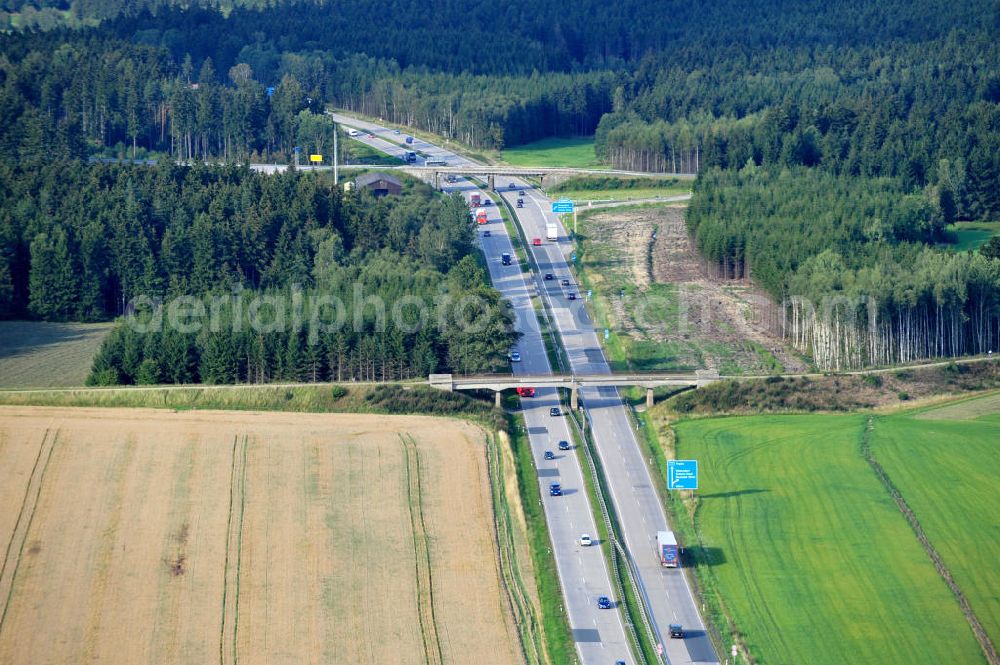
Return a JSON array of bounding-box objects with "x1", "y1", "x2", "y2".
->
[{"x1": 0, "y1": 407, "x2": 520, "y2": 665}]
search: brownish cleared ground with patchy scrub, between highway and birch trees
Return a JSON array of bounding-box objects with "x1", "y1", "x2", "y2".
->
[{"x1": 580, "y1": 206, "x2": 806, "y2": 374}]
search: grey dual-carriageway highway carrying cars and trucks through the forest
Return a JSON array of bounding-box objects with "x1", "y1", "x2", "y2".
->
[{"x1": 334, "y1": 115, "x2": 718, "y2": 665}]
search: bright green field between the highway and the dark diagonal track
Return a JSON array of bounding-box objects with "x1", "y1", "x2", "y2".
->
[{"x1": 676, "y1": 415, "x2": 984, "y2": 665}]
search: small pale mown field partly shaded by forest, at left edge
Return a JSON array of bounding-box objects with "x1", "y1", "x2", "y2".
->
[{"x1": 0, "y1": 321, "x2": 112, "y2": 388}]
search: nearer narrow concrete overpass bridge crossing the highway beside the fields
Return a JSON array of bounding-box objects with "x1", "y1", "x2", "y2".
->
[{"x1": 427, "y1": 370, "x2": 719, "y2": 409}]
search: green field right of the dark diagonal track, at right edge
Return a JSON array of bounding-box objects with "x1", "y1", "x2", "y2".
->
[{"x1": 871, "y1": 395, "x2": 1000, "y2": 644}]
